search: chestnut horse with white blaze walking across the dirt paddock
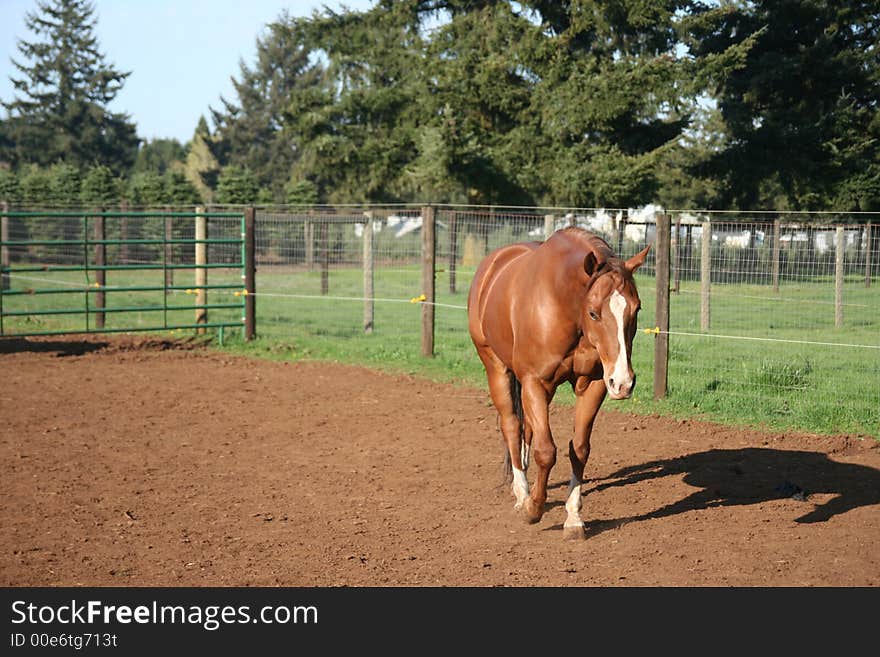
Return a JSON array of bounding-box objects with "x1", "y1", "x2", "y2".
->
[{"x1": 468, "y1": 228, "x2": 651, "y2": 538}]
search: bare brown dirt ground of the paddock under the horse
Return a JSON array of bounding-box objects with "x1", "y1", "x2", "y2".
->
[{"x1": 0, "y1": 337, "x2": 880, "y2": 586}]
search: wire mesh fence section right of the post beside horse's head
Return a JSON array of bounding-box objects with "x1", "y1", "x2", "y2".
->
[{"x1": 669, "y1": 213, "x2": 880, "y2": 435}]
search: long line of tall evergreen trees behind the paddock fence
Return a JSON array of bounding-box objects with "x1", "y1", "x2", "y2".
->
[{"x1": 0, "y1": 0, "x2": 880, "y2": 211}]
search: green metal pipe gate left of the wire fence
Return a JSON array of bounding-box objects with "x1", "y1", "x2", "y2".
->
[{"x1": 0, "y1": 209, "x2": 254, "y2": 340}]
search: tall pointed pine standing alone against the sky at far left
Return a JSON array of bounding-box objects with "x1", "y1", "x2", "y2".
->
[{"x1": 2, "y1": 0, "x2": 138, "y2": 174}]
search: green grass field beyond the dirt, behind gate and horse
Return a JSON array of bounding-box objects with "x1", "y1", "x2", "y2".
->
[{"x1": 4, "y1": 265, "x2": 880, "y2": 438}]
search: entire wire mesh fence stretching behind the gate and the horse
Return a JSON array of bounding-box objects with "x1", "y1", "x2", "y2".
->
[{"x1": 4, "y1": 206, "x2": 880, "y2": 435}]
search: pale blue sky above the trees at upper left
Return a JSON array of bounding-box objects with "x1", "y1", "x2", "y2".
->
[{"x1": 0, "y1": 0, "x2": 374, "y2": 142}]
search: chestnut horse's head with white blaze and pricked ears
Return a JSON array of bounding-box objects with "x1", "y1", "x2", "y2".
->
[{"x1": 581, "y1": 245, "x2": 651, "y2": 399}]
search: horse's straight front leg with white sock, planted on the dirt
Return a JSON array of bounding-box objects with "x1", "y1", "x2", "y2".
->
[{"x1": 562, "y1": 377, "x2": 607, "y2": 540}]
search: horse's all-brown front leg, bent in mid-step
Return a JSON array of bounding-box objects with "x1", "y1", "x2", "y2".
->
[{"x1": 522, "y1": 377, "x2": 556, "y2": 523}]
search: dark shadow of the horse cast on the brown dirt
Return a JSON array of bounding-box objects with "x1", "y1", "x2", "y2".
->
[{"x1": 553, "y1": 448, "x2": 880, "y2": 537}]
